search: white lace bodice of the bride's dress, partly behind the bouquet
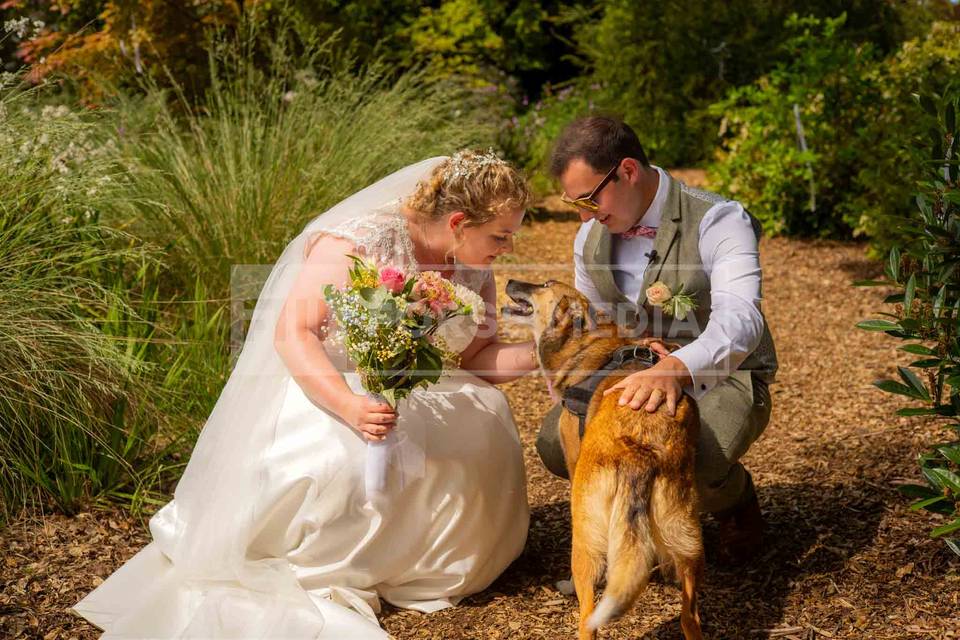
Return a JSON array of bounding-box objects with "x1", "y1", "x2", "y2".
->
[{"x1": 308, "y1": 200, "x2": 493, "y2": 352}]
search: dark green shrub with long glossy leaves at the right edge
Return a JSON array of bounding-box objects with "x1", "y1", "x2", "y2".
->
[{"x1": 858, "y1": 92, "x2": 960, "y2": 555}]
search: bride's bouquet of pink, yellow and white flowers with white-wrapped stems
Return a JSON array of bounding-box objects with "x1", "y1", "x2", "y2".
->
[{"x1": 324, "y1": 256, "x2": 484, "y2": 498}]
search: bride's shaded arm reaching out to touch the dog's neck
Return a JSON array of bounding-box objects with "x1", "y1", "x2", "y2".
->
[{"x1": 460, "y1": 274, "x2": 538, "y2": 384}]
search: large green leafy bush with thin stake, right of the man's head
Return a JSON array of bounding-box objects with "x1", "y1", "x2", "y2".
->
[{"x1": 710, "y1": 16, "x2": 881, "y2": 237}]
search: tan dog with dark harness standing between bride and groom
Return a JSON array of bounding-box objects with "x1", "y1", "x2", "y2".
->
[{"x1": 504, "y1": 280, "x2": 703, "y2": 640}]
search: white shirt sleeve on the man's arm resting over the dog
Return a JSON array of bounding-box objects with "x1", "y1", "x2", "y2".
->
[{"x1": 668, "y1": 202, "x2": 764, "y2": 400}]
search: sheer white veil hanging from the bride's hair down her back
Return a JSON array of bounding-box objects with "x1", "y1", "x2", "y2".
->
[{"x1": 150, "y1": 157, "x2": 445, "y2": 632}]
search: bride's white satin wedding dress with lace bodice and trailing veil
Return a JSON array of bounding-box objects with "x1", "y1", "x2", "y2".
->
[{"x1": 73, "y1": 160, "x2": 529, "y2": 640}]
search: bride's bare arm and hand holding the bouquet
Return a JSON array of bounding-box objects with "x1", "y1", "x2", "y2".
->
[{"x1": 273, "y1": 236, "x2": 396, "y2": 440}]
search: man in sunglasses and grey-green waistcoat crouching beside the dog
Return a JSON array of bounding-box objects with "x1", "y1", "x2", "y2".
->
[{"x1": 537, "y1": 116, "x2": 777, "y2": 562}]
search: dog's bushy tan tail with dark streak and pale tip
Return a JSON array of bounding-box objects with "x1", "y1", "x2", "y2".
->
[{"x1": 587, "y1": 445, "x2": 659, "y2": 630}]
